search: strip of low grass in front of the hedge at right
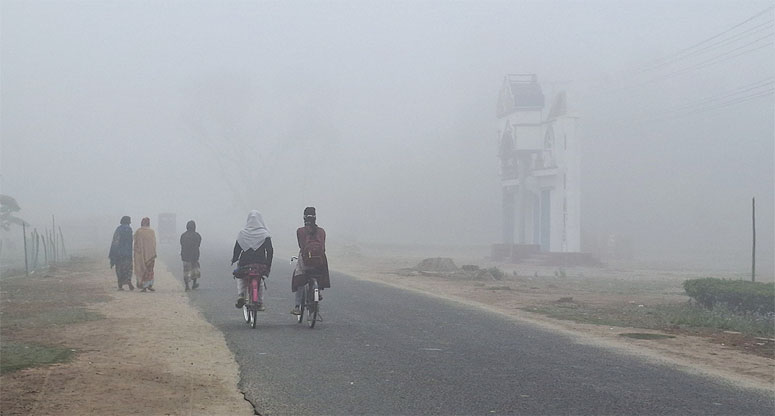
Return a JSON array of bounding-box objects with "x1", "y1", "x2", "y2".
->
[{"x1": 526, "y1": 303, "x2": 775, "y2": 338}]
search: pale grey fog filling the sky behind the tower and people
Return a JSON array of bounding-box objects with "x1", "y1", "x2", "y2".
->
[{"x1": 0, "y1": 1, "x2": 775, "y2": 276}]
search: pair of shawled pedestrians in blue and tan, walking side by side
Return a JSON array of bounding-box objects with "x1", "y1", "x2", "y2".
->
[{"x1": 108, "y1": 216, "x2": 156, "y2": 292}]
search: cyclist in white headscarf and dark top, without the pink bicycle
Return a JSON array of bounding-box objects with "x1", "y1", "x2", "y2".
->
[{"x1": 231, "y1": 210, "x2": 274, "y2": 311}]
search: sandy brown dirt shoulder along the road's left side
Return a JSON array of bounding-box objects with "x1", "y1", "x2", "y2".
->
[{"x1": 0, "y1": 260, "x2": 253, "y2": 415}]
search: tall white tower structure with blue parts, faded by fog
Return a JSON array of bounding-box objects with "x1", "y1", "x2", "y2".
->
[{"x1": 497, "y1": 74, "x2": 581, "y2": 253}]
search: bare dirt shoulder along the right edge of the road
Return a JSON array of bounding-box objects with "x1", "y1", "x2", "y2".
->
[{"x1": 332, "y1": 254, "x2": 775, "y2": 393}]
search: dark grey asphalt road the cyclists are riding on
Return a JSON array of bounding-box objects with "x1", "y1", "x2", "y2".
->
[{"x1": 161, "y1": 247, "x2": 775, "y2": 415}]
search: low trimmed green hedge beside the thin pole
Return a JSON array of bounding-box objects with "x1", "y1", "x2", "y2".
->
[{"x1": 684, "y1": 277, "x2": 775, "y2": 313}]
